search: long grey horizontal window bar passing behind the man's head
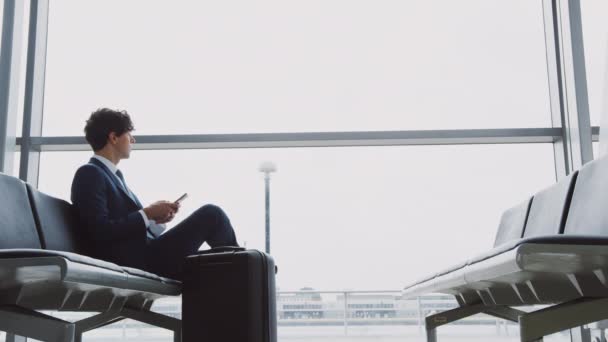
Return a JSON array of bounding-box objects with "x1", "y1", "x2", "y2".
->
[{"x1": 17, "y1": 128, "x2": 564, "y2": 151}]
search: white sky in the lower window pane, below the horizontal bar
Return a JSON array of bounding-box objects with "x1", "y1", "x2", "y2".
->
[{"x1": 39, "y1": 144, "x2": 555, "y2": 290}]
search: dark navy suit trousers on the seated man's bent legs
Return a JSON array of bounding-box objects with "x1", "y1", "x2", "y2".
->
[{"x1": 145, "y1": 204, "x2": 238, "y2": 280}]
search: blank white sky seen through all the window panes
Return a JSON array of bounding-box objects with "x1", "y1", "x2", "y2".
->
[{"x1": 4, "y1": 0, "x2": 608, "y2": 290}]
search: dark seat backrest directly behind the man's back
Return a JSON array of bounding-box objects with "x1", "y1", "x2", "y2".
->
[{"x1": 27, "y1": 184, "x2": 87, "y2": 255}]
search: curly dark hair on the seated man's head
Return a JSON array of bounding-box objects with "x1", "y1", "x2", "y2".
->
[{"x1": 84, "y1": 108, "x2": 134, "y2": 151}]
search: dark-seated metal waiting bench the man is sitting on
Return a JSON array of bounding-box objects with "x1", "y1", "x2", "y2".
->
[{"x1": 0, "y1": 174, "x2": 181, "y2": 342}]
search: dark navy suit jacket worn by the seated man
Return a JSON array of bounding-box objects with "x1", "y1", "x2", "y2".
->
[{"x1": 71, "y1": 158, "x2": 147, "y2": 268}]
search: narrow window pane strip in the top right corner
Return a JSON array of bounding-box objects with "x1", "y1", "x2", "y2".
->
[{"x1": 581, "y1": 0, "x2": 608, "y2": 126}]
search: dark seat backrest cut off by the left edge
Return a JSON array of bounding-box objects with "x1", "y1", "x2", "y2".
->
[{"x1": 0, "y1": 173, "x2": 41, "y2": 249}]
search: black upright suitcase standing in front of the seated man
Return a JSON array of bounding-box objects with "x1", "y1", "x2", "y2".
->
[{"x1": 182, "y1": 247, "x2": 277, "y2": 342}]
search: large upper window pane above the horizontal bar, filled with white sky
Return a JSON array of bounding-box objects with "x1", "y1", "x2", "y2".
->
[{"x1": 43, "y1": 0, "x2": 551, "y2": 135}]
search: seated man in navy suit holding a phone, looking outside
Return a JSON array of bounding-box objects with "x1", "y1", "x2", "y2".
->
[{"x1": 72, "y1": 108, "x2": 238, "y2": 280}]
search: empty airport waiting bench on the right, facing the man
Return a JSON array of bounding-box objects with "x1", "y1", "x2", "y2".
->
[{"x1": 403, "y1": 158, "x2": 608, "y2": 341}]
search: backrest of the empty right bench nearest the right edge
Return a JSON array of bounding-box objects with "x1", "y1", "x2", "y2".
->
[{"x1": 564, "y1": 157, "x2": 608, "y2": 236}]
